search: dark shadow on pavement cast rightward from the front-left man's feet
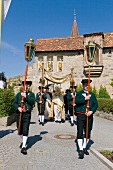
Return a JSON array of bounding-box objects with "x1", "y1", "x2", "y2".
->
[{"x1": 27, "y1": 131, "x2": 48, "y2": 149}]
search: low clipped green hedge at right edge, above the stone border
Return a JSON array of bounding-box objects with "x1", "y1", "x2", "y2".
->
[{"x1": 97, "y1": 98, "x2": 113, "y2": 113}]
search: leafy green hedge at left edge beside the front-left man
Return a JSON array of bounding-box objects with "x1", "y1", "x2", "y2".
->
[{"x1": 0, "y1": 89, "x2": 15, "y2": 117}]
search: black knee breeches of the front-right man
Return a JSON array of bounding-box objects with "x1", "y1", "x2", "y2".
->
[{"x1": 77, "y1": 114, "x2": 93, "y2": 139}]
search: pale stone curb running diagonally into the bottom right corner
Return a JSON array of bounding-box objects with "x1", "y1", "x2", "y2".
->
[{"x1": 90, "y1": 148, "x2": 113, "y2": 170}]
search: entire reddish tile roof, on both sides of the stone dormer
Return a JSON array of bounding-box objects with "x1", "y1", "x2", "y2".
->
[{"x1": 35, "y1": 32, "x2": 113, "y2": 52}]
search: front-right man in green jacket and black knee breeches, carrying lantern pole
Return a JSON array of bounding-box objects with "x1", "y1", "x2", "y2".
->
[{"x1": 76, "y1": 79, "x2": 98, "y2": 159}]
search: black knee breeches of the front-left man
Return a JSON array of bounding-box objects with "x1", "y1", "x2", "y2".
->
[{"x1": 17, "y1": 112, "x2": 31, "y2": 136}]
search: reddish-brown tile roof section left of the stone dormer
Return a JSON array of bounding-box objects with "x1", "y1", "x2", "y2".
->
[{"x1": 35, "y1": 36, "x2": 83, "y2": 52}]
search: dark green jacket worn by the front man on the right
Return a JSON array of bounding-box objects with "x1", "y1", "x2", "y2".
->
[{"x1": 75, "y1": 90, "x2": 98, "y2": 113}]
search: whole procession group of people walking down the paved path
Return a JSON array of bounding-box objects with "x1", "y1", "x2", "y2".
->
[{"x1": 13, "y1": 79, "x2": 98, "y2": 159}]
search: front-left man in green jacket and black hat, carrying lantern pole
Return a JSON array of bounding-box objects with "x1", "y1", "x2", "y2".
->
[{"x1": 13, "y1": 81, "x2": 35, "y2": 154}]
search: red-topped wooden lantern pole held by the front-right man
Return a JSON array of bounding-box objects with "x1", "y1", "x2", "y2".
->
[{"x1": 86, "y1": 66, "x2": 90, "y2": 141}]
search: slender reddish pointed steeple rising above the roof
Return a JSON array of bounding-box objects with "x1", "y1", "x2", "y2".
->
[{"x1": 71, "y1": 10, "x2": 78, "y2": 37}]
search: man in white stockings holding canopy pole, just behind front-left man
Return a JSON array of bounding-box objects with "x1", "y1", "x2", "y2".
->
[{"x1": 36, "y1": 86, "x2": 47, "y2": 126}]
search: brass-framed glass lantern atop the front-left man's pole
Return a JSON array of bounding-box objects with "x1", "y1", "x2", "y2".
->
[{"x1": 24, "y1": 38, "x2": 35, "y2": 62}]
